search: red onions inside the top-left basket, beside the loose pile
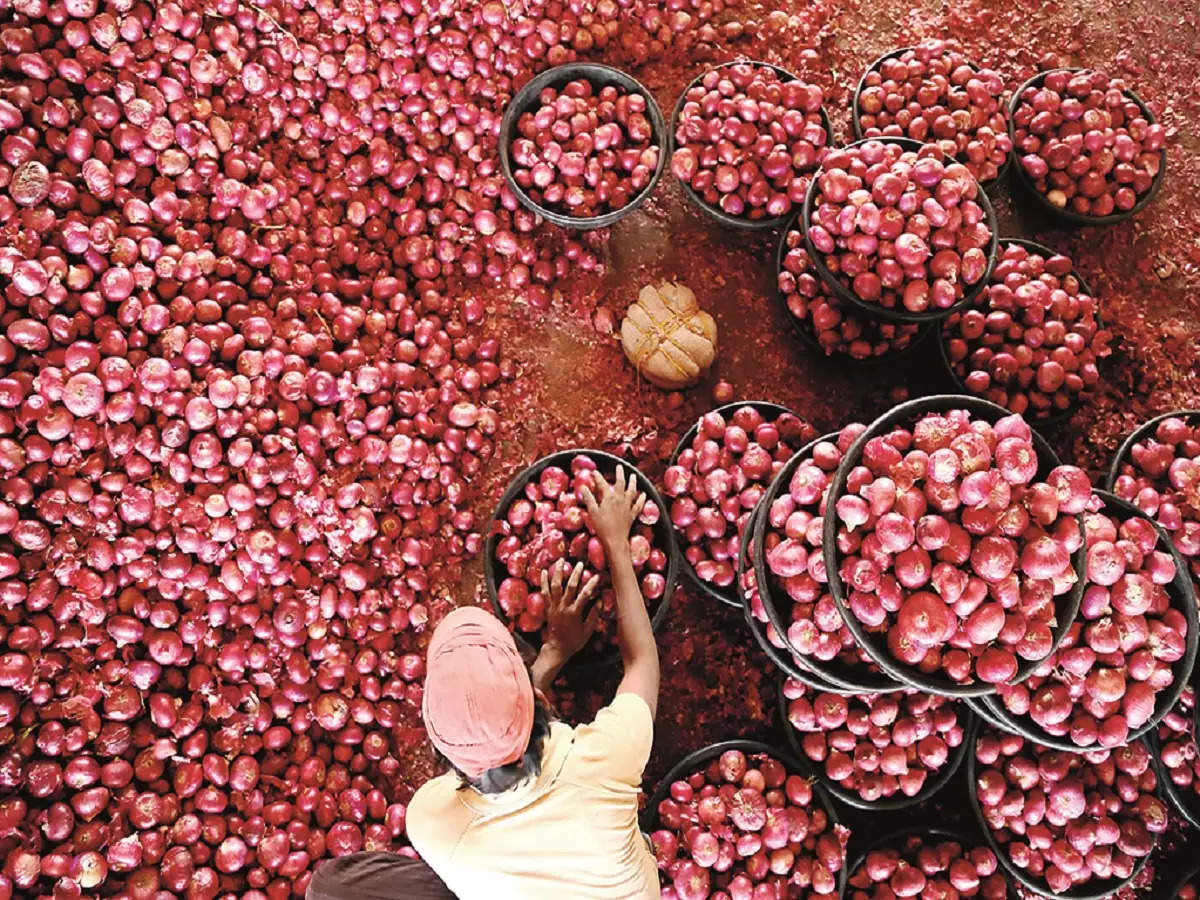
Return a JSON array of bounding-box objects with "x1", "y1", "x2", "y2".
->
[{"x1": 510, "y1": 78, "x2": 661, "y2": 218}]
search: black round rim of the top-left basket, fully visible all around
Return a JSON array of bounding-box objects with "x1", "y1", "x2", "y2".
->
[{"x1": 498, "y1": 62, "x2": 670, "y2": 230}]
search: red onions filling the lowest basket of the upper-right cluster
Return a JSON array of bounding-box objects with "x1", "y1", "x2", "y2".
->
[{"x1": 942, "y1": 241, "x2": 1111, "y2": 419}]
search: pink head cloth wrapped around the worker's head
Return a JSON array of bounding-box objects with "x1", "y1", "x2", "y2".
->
[{"x1": 421, "y1": 606, "x2": 534, "y2": 778}]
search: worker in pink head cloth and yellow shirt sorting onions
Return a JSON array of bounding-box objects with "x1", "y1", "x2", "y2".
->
[{"x1": 310, "y1": 468, "x2": 659, "y2": 900}]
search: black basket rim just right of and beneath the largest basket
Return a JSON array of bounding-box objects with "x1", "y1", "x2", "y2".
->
[{"x1": 982, "y1": 491, "x2": 1200, "y2": 754}]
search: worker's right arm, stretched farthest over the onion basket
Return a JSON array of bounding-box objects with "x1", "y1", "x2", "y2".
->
[{"x1": 582, "y1": 467, "x2": 659, "y2": 716}]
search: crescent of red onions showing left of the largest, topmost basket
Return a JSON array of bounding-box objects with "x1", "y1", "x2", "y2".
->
[{"x1": 751, "y1": 422, "x2": 883, "y2": 666}]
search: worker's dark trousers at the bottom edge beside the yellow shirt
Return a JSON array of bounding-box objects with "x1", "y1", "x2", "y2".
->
[{"x1": 307, "y1": 851, "x2": 455, "y2": 900}]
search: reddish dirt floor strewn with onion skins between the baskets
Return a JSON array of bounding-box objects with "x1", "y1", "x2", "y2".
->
[{"x1": 434, "y1": 0, "x2": 1200, "y2": 895}]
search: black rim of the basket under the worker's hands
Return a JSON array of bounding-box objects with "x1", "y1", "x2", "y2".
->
[{"x1": 484, "y1": 449, "x2": 679, "y2": 670}]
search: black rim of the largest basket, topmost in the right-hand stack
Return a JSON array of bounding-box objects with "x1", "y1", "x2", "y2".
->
[{"x1": 824, "y1": 394, "x2": 1085, "y2": 697}]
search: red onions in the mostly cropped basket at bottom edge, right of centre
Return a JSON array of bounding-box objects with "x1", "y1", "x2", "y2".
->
[{"x1": 846, "y1": 834, "x2": 1008, "y2": 900}]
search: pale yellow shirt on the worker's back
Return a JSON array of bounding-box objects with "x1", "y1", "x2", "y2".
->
[{"x1": 407, "y1": 694, "x2": 659, "y2": 900}]
